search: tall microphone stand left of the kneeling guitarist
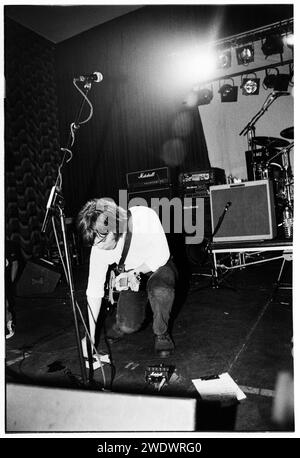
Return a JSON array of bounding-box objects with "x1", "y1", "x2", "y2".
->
[{"x1": 41, "y1": 82, "x2": 95, "y2": 385}]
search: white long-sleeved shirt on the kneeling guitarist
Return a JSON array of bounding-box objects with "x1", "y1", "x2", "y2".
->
[{"x1": 86, "y1": 206, "x2": 170, "y2": 298}]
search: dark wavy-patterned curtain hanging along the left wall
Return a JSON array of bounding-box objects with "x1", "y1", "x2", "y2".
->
[{"x1": 5, "y1": 18, "x2": 60, "y2": 258}]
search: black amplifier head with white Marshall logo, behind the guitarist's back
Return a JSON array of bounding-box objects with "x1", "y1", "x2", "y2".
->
[{"x1": 126, "y1": 167, "x2": 170, "y2": 190}]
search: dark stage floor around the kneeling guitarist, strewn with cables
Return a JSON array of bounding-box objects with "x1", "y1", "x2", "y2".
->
[{"x1": 6, "y1": 250, "x2": 293, "y2": 432}]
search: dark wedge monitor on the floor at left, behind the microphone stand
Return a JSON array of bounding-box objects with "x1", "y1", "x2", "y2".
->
[{"x1": 16, "y1": 260, "x2": 61, "y2": 297}]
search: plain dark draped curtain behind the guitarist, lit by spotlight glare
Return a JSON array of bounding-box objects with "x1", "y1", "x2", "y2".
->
[{"x1": 57, "y1": 7, "x2": 217, "y2": 216}]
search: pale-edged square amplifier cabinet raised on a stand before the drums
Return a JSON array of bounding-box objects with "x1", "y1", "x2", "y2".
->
[{"x1": 210, "y1": 180, "x2": 277, "y2": 242}]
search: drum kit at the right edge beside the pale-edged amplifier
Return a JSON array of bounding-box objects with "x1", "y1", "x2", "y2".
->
[{"x1": 252, "y1": 127, "x2": 294, "y2": 238}]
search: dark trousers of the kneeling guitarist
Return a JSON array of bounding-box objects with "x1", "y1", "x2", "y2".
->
[{"x1": 116, "y1": 259, "x2": 178, "y2": 335}]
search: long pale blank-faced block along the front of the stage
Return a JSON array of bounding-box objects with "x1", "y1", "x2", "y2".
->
[{"x1": 6, "y1": 383, "x2": 197, "y2": 433}]
